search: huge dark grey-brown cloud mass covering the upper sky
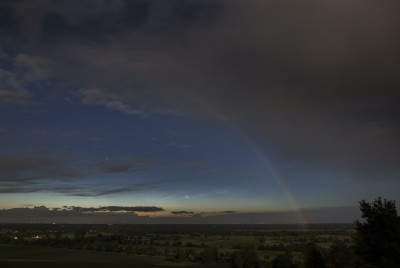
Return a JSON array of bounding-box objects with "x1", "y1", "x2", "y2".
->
[{"x1": 0, "y1": 0, "x2": 400, "y2": 179}]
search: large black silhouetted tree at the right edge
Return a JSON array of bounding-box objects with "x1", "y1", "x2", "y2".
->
[{"x1": 354, "y1": 197, "x2": 400, "y2": 268}]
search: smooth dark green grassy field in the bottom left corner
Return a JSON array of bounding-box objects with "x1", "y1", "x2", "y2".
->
[{"x1": 0, "y1": 246, "x2": 197, "y2": 268}]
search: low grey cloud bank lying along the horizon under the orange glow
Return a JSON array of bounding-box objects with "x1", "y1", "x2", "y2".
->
[{"x1": 0, "y1": 206, "x2": 359, "y2": 224}]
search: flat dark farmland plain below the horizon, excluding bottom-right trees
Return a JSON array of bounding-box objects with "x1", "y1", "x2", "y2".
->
[{"x1": 0, "y1": 224, "x2": 354, "y2": 268}]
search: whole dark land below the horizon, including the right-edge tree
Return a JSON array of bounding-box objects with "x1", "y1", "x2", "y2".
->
[{"x1": 0, "y1": 198, "x2": 400, "y2": 268}]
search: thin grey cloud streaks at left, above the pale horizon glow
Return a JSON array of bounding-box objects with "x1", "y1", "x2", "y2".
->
[{"x1": 0, "y1": 154, "x2": 210, "y2": 197}]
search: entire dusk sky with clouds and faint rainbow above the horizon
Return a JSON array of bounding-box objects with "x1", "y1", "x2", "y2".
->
[{"x1": 0, "y1": 0, "x2": 400, "y2": 223}]
